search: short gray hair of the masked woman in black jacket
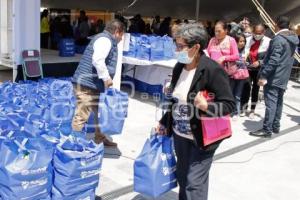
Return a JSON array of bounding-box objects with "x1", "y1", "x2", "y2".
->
[{"x1": 175, "y1": 22, "x2": 209, "y2": 54}]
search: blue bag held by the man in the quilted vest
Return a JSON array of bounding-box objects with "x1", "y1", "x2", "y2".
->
[{"x1": 98, "y1": 88, "x2": 128, "y2": 135}]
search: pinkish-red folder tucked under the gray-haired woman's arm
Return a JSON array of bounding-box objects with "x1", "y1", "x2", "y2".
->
[{"x1": 201, "y1": 91, "x2": 232, "y2": 146}]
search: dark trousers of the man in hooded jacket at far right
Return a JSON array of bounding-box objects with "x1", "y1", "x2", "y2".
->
[{"x1": 264, "y1": 85, "x2": 285, "y2": 133}]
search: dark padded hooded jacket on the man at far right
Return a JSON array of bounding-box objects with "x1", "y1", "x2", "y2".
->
[{"x1": 259, "y1": 31, "x2": 299, "y2": 90}]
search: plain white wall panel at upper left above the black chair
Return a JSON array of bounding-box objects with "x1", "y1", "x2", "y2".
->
[{"x1": 13, "y1": 0, "x2": 41, "y2": 65}]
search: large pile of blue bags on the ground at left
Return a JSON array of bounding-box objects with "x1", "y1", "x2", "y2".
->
[{"x1": 0, "y1": 79, "x2": 104, "y2": 200}]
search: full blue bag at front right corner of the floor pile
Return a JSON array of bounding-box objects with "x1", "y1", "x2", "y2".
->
[{"x1": 52, "y1": 136, "x2": 104, "y2": 200}]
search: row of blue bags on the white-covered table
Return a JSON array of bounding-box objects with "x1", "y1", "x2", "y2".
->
[{"x1": 124, "y1": 34, "x2": 176, "y2": 61}]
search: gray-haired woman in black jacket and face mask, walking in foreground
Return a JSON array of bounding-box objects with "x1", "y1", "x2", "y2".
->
[{"x1": 156, "y1": 23, "x2": 235, "y2": 200}]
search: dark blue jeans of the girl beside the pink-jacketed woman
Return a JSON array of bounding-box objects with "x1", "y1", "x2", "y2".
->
[{"x1": 230, "y1": 79, "x2": 246, "y2": 115}]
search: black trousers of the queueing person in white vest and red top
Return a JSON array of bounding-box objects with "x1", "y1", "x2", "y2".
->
[{"x1": 241, "y1": 71, "x2": 259, "y2": 112}]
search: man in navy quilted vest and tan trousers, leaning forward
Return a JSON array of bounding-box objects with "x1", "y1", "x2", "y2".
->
[{"x1": 72, "y1": 20, "x2": 125, "y2": 147}]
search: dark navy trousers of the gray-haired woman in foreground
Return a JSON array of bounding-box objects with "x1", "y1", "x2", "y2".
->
[{"x1": 174, "y1": 134, "x2": 215, "y2": 200}]
